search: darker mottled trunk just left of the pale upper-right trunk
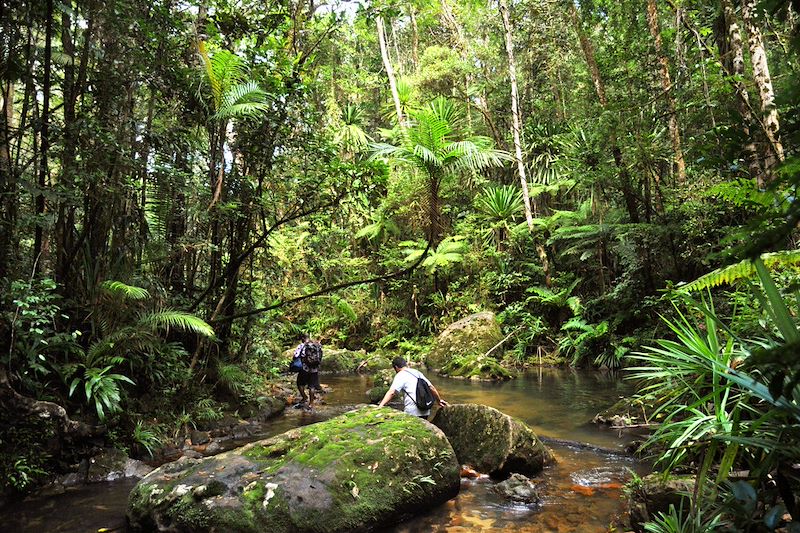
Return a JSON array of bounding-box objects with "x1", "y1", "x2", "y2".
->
[{"x1": 719, "y1": 0, "x2": 764, "y2": 183}]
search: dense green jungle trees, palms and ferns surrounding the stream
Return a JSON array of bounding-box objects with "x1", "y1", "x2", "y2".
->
[{"x1": 0, "y1": 0, "x2": 800, "y2": 531}]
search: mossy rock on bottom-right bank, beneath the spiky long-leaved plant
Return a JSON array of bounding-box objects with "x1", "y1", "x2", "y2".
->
[{"x1": 626, "y1": 474, "x2": 694, "y2": 531}]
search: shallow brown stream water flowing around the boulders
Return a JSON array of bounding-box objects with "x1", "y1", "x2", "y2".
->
[{"x1": 0, "y1": 369, "x2": 646, "y2": 533}]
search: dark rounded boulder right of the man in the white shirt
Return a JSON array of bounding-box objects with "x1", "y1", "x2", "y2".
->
[{"x1": 433, "y1": 403, "x2": 553, "y2": 479}]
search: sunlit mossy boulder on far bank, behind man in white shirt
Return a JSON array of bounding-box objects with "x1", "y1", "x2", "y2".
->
[{"x1": 425, "y1": 311, "x2": 511, "y2": 379}]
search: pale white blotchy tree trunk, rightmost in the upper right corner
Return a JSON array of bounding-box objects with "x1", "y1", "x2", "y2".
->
[{"x1": 742, "y1": 0, "x2": 784, "y2": 175}]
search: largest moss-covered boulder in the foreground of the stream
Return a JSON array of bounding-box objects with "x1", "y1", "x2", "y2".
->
[{"x1": 126, "y1": 407, "x2": 460, "y2": 533}]
